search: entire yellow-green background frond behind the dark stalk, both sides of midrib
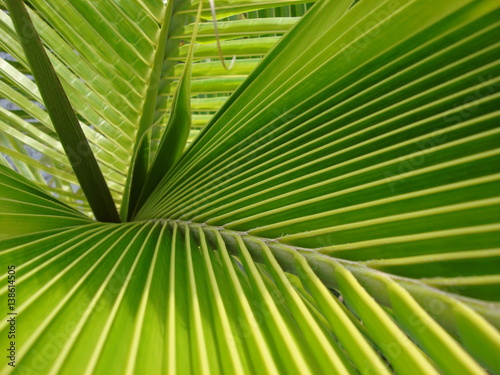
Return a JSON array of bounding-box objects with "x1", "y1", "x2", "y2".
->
[{"x1": 0, "y1": 0, "x2": 307, "y2": 216}]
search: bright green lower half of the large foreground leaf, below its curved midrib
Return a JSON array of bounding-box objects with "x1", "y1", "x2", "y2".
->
[{"x1": 0, "y1": 167, "x2": 499, "y2": 374}]
